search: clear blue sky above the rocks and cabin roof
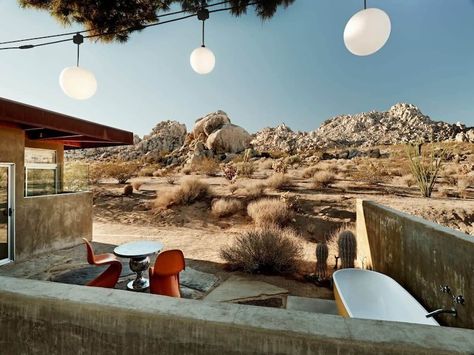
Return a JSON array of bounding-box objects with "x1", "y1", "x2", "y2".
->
[{"x1": 0, "y1": 0, "x2": 474, "y2": 135}]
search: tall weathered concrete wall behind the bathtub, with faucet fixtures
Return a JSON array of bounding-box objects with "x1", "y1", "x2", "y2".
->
[{"x1": 357, "y1": 200, "x2": 474, "y2": 329}]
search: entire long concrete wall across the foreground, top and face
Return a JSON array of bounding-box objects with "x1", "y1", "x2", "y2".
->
[{"x1": 0, "y1": 277, "x2": 474, "y2": 355}]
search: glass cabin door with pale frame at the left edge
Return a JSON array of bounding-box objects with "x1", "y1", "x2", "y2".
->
[{"x1": 0, "y1": 163, "x2": 13, "y2": 265}]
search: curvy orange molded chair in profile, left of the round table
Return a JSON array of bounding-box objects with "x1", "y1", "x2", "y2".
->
[{"x1": 82, "y1": 238, "x2": 122, "y2": 288}]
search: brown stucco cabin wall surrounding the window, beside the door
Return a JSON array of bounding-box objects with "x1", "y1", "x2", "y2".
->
[{"x1": 0, "y1": 122, "x2": 92, "y2": 260}]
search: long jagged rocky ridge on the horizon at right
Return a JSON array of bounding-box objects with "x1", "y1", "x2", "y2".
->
[{"x1": 252, "y1": 103, "x2": 474, "y2": 153}]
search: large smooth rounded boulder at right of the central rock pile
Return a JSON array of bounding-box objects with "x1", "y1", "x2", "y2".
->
[{"x1": 206, "y1": 124, "x2": 252, "y2": 154}]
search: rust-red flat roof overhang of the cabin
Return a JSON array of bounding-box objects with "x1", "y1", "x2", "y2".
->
[{"x1": 0, "y1": 98, "x2": 133, "y2": 149}]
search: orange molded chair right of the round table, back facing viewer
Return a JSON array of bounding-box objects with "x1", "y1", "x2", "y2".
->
[{"x1": 149, "y1": 249, "x2": 186, "y2": 298}]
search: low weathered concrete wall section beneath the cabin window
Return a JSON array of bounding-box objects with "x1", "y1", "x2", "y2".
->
[{"x1": 16, "y1": 192, "x2": 92, "y2": 260}]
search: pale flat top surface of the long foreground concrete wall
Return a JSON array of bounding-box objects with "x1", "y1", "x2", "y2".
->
[{"x1": 0, "y1": 277, "x2": 474, "y2": 353}]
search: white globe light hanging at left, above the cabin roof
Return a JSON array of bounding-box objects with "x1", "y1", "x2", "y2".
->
[{"x1": 59, "y1": 67, "x2": 97, "y2": 100}]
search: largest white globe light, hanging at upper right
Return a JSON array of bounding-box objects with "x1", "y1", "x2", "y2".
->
[{"x1": 344, "y1": 8, "x2": 392, "y2": 56}]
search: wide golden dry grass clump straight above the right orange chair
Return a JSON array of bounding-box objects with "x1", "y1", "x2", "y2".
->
[{"x1": 155, "y1": 177, "x2": 211, "y2": 208}]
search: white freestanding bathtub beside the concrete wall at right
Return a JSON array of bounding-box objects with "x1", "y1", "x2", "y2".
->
[{"x1": 333, "y1": 269, "x2": 439, "y2": 326}]
